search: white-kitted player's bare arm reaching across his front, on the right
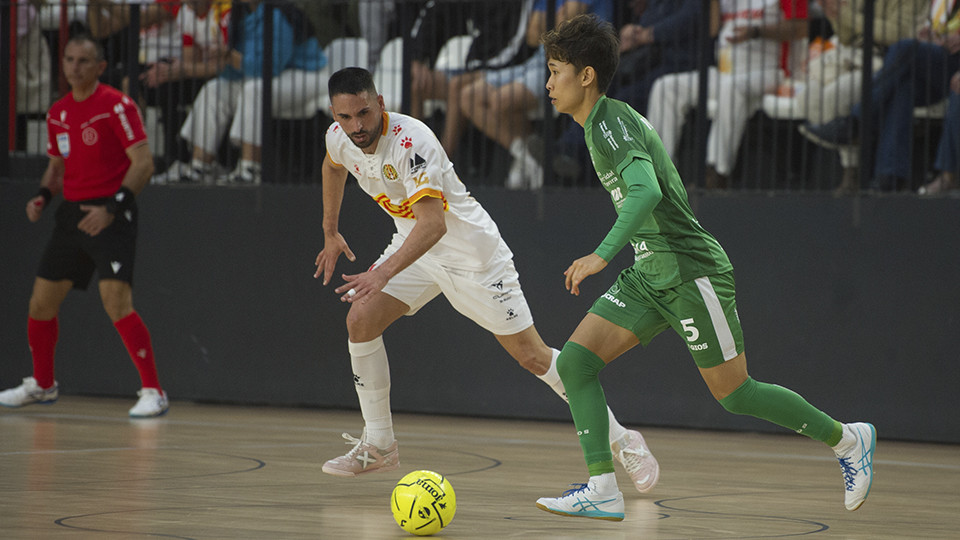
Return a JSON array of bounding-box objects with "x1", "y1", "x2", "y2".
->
[{"x1": 336, "y1": 196, "x2": 447, "y2": 302}]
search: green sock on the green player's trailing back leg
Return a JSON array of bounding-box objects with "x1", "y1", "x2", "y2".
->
[{"x1": 720, "y1": 377, "x2": 843, "y2": 446}]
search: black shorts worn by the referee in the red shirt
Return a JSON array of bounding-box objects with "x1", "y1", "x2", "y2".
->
[{"x1": 37, "y1": 199, "x2": 137, "y2": 290}]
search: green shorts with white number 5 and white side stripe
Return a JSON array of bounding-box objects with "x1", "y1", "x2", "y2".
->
[{"x1": 590, "y1": 266, "x2": 743, "y2": 368}]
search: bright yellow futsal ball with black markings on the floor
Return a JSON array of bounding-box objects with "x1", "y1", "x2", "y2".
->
[{"x1": 390, "y1": 471, "x2": 457, "y2": 536}]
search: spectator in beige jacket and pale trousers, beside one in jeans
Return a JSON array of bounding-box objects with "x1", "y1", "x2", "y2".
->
[{"x1": 797, "y1": 0, "x2": 929, "y2": 195}]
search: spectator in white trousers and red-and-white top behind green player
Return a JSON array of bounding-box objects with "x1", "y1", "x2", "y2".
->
[{"x1": 647, "y1": 0, "x2": 807, "y2": 188}]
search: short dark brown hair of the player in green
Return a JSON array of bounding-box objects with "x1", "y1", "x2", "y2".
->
[{"x1": 540, "y1": 13, "x2": 620, "y2": 93}]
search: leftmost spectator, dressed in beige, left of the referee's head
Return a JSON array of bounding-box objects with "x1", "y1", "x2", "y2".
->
[{"x1": 16, "y1": 0, "x2": 54, "y2": 120}]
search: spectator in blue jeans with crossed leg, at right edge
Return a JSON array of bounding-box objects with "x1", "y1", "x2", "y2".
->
[{"x1": 800, "y1": 0, "x2": 960, "y2": 191}]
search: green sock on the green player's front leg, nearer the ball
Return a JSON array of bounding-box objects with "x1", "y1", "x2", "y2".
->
[{"x1": 557, "y1": 341, "x2": 613, "y2": 476}]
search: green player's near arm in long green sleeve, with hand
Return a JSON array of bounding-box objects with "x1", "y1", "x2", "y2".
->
[{"x1": 563, "y1": 158, "x2": 663, "y2": 295}]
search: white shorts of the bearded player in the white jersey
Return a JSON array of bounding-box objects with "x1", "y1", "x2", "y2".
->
[{"x1": 374, "y1": 236, "x2": 533, "y2": 336}]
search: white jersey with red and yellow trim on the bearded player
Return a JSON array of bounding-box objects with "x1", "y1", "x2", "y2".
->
[{"x1": 326, "y1": 112, "x2": 513, "y2": 271}]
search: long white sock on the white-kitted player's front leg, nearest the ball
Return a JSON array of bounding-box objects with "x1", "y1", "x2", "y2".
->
[{"x1": 347, "y1": 336, "x2": 395, "y2": 448}]
